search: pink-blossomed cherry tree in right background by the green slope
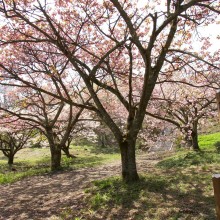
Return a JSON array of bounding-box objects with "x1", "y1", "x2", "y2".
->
[{"x1": 147, "y1": 83, "x2": 216, "y2": 151}]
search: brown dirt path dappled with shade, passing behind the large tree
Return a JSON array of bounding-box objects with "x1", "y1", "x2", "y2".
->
[{"x1": 0, "y1": 155, "x2": 161, "y2": 220}]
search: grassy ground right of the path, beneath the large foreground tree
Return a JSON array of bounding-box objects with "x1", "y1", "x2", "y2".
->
[{"x1": 70, "y1": 133, "x2": 220, "y2": 220}]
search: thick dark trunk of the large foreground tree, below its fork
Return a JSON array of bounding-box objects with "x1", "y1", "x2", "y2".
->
[{"x1": 120, "y1": 140, "x2": 139, "y2": 183}]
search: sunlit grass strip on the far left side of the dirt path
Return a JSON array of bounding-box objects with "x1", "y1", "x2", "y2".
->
[{"x1": 0, "y1": 146, "x2": 119, "y2": 184}]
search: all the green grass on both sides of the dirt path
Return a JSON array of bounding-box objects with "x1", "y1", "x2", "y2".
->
[{"x1": 0, "y1": 133, "x2": 220, "y2": 220}]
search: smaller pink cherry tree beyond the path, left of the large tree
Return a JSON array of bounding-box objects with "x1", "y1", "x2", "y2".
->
[{"x1": 0, "y1": 88, "x2": 83, "y2": 171}]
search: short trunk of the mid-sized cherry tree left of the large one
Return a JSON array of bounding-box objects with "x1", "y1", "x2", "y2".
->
[{"x1": 50, "y1": 146, "x2": 61, "y2": 171}]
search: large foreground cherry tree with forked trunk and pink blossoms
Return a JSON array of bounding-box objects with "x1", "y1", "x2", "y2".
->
[{"x1": 0, "y1": 0, "x2": 219, "y2": 182}]
